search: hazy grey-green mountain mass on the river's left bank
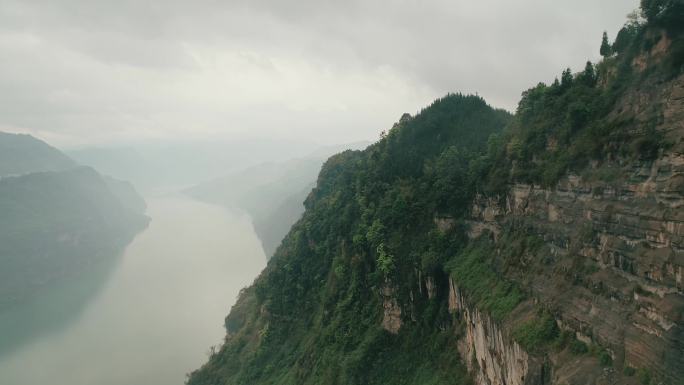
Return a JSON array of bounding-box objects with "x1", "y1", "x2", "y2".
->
[{"x1": 0, "y1": 133, "x2": 149, "y2": 311}]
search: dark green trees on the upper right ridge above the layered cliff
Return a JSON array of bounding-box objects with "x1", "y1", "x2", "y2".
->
[{"x1": 480, "y1": 12, "x2": 684, "y2": 192}]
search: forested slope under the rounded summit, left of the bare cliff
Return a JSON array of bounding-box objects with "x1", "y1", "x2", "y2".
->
[{"x1": 190, "y1": 95, "x2": 509, "y2": 384}]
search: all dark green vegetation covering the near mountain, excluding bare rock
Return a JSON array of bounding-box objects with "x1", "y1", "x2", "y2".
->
[{"x1": 188, "y1": 5, "x2": 682, "y2": 385}]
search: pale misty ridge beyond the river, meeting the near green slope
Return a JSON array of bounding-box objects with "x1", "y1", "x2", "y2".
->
[{"x1": 185, "y1": 142, "x2": 368, "y2": 258}]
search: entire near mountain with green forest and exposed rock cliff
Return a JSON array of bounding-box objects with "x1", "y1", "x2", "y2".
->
[{"x1": 188, "y1": 5, "x2": 684, "y2": 385}]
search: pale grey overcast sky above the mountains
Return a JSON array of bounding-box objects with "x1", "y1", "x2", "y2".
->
[{"x1": 0, "y1": 0, "x2": 638, "y2": 146}]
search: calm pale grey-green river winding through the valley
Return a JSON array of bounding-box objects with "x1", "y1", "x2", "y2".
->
[{"x1": 0, "y1": 197, "x2": 266, "y2": 385}]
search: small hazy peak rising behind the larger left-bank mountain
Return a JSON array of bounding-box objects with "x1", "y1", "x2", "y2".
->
[{"x1": 0, "y1": 132, "x2": 76, "y2": 177}]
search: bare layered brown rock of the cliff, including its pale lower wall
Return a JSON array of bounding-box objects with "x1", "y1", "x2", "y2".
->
[{"x1": 383, "y1": 41, "x2": 684, "y2": 385}]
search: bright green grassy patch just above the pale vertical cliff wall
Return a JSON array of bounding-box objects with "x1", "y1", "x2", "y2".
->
[{"x1": 446, "y1": 238, "x2": 525, "y2": 321}]
